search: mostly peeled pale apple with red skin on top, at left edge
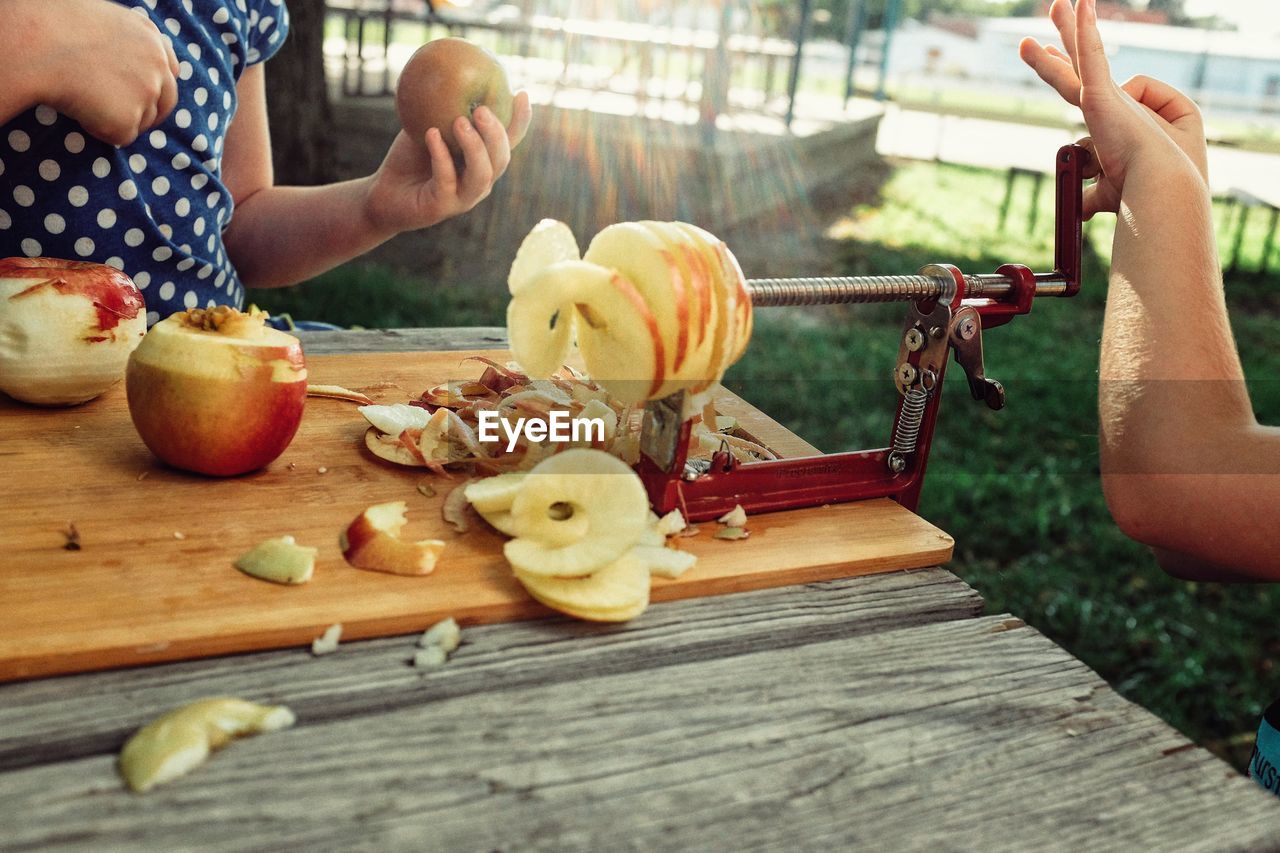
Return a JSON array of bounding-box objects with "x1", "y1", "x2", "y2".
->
[{"x1": 0, "y1": 257, "x2": 147, "y2": 406}]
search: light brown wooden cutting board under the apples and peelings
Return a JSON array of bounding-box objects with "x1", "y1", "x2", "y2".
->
[{"x1": 0, "y1": 352, "x2": 952, "y2": 681}]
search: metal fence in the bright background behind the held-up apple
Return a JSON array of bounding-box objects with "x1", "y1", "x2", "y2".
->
[{"x1": 329, "y1": 0, "x2": 896, "y2": 127}]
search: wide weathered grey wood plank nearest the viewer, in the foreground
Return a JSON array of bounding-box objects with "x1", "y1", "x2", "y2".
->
[{"x1": 0, "y1": 616, "x2": 1280, "y2": 850}]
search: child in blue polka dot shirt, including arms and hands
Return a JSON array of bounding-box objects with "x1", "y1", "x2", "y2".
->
[{"x1": 0, "y1": 0, "x2": 530, "y2": 323}]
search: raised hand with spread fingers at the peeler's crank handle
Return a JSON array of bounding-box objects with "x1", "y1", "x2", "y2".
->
[{"x1": 1019, "y1": 0, "x2": 1208, "y2": 219}]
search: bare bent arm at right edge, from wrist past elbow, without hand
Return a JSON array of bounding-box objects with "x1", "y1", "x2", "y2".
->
[{"x1": 1098, "y1": 156, "x2": 1280, "y2": 580}]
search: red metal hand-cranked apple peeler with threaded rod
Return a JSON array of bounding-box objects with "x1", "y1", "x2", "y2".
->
[{"x1": 636, "y1": 145, "x2": 1089, "y2": 521}]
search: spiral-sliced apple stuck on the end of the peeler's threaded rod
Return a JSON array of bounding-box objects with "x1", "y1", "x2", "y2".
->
[{"x1": 507, "y1": 219, "x2": 753, "y2": 403}]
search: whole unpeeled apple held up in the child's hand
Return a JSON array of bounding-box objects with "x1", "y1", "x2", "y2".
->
[{"x1": 396, "y1": 38, "x2": 512, "y2": 159}]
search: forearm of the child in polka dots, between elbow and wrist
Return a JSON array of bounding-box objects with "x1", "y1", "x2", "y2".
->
[{"x1": 223, "y1": 178, "x2": 394, "y2": 287}]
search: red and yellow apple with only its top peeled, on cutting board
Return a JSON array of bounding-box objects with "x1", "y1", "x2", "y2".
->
[{"x1": 125, "y1": 306, "x2": 307, "y2": 476}]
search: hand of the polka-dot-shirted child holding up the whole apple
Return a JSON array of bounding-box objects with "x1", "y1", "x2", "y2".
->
[{"x1": 366, "y1": 92, "x2": 532, "y2": 233}]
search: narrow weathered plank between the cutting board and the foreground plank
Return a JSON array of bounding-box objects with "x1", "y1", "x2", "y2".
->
[{"x1": 0, "y1": 569, "x2": 982, "y2": 768}]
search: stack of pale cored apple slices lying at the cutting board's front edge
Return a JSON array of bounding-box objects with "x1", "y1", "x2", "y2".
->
[{"x1": 466, "y1": 448, "x2": 696, "y2": 622}]
